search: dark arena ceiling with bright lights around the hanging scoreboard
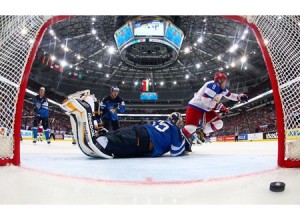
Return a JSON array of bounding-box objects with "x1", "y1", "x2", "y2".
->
[{"x1": 33, "y1": 16, "x2": 268, "y2": 91}]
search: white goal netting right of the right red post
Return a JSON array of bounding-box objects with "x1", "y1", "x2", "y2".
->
[{"x1": 247, "y1": 16, "x2": 300, "y2": 162}]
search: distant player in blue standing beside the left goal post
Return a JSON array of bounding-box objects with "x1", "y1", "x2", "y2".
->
[{"x1": 32, "y1": 87, "x2": 50, "y2": 144}]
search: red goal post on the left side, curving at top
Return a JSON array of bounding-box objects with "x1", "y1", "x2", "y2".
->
[{"x1": 0, "y1": 15, "x2": 72, "y2": 166}]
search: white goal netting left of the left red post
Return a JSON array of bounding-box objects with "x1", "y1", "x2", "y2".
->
[{"x1": 0, "y1": 16, "x2": 49, "y2": 160}]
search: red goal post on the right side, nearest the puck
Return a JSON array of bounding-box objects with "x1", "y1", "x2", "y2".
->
[{"x1": 225, "y1": 16, "x2": 292, "y2": 168}]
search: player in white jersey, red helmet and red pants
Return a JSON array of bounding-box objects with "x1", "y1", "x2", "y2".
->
[{"x1": 182, "y1": 72, "x2": 248, "y2": 141}]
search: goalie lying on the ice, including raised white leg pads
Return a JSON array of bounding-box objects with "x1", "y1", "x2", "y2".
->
[{"x1": 62, "y1": 90, "x2": 191, "y2": 158}]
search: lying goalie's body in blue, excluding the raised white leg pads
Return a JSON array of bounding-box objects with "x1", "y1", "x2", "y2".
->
[{"x1": 95, "y1": 112, "x2": 190, "y2": 157}]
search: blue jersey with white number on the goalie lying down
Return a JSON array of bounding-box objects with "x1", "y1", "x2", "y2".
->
[{"x1": 144, "y1": 120, "x2": 185, "y2": 157}]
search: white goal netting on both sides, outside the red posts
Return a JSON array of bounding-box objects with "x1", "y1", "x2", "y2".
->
[{"x1": 0, "y1": 16, "x2": 300, "y2": 166}]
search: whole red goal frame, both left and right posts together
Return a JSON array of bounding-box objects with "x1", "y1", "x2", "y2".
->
[{"x1": 0, "y1": 15, "x2": 292, "y2": 167}]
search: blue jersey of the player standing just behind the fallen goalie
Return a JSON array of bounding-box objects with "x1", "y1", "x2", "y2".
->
[{"x1": 100, "y1": 96, "x2": 125, "y2": 121}]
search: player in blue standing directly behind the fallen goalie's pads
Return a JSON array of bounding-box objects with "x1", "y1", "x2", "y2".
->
[{"x1": 100, "y1": 86, "x2": 125, "y2": 131}]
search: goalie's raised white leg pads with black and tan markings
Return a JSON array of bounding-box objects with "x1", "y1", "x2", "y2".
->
[{"x1": 62, "y1": 93, "x2": 112, "y2": 158}]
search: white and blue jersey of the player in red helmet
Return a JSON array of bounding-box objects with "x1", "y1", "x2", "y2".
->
[{"x1": 188, "y1": 80, "x2": 239, "y2": 112}]
